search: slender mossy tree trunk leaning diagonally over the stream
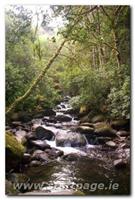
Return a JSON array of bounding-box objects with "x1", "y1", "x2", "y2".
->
[{"x1": 6, "y1": 40, "x2": 66, "y2": 115}]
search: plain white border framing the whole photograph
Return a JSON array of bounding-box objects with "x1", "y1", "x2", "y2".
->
[{"x1": 0, "y1": 0, "x2": 135, "y2": 199}]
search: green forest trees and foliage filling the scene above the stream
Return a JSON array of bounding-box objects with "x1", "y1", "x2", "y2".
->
[{"x1": 5, "y1": 6, "x2": 130, "y2": 119}]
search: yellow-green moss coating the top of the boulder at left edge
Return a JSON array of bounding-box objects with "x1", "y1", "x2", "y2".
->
[{"x1": 6, "y1": 132, "x2": 25, "y2": 157}]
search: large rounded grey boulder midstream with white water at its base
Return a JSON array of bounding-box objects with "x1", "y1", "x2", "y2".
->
[{"x1": 56, "y1": 132, "x2": 86, "y2": 147}]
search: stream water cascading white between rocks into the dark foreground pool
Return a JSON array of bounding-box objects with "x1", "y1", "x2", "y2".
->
[{"x1": 21, "y1": 97, "x2": 130, "y2": 195}]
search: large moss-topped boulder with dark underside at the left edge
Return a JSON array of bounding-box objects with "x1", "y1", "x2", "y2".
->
[{"x1": 6, "y1": 132, "x2": 25, "y2": 171}]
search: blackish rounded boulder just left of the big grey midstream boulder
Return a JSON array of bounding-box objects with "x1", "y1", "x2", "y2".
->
[{"x1": 35, "y1": 126, "x2": 54, "y2": 140}]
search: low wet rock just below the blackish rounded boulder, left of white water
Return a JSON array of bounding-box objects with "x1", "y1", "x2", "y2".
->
[{"x1": 30, "y1": 140, "x2": 50, "y2": 150}]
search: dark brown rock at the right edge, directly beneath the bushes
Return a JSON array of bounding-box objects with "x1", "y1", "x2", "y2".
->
[{"x1": 111, "y1": 119, "x2": 130, "y2": 130}]
